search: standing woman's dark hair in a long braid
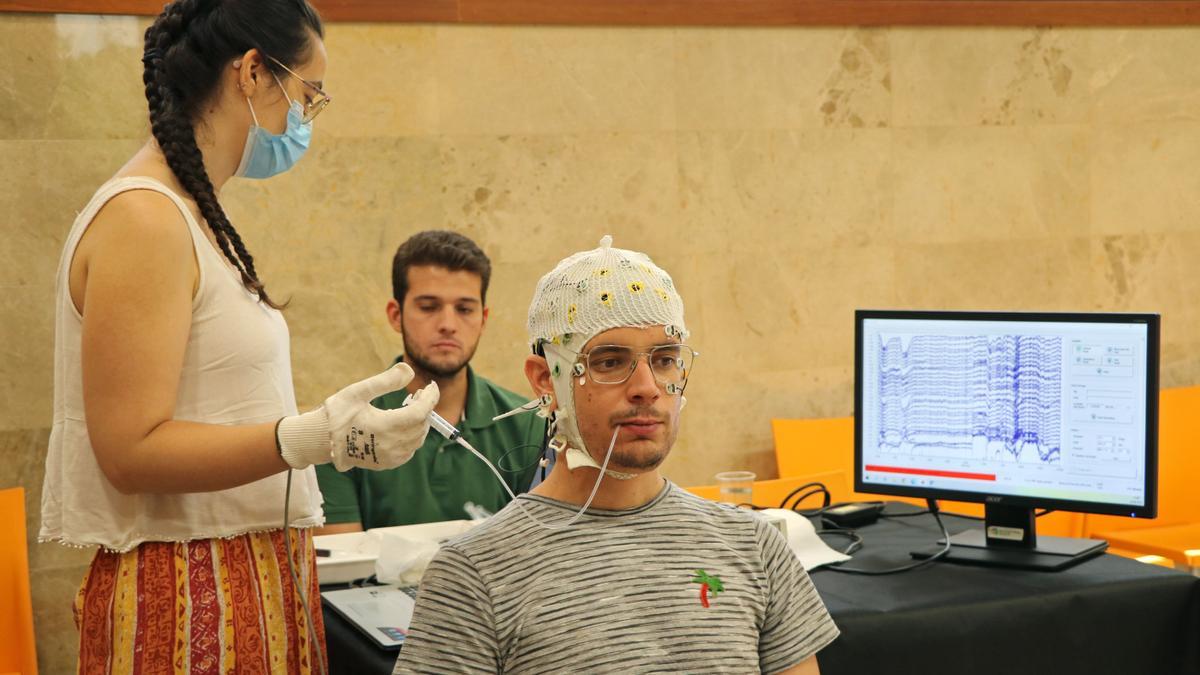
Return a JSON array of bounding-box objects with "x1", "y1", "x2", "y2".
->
[{"x1": 142, "y1": 0, "x2": 323, "y2": 309}]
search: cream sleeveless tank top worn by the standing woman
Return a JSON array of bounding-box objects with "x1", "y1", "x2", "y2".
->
[{"x1": 38, "y1": 178, "x2": 324, "y2": 551}]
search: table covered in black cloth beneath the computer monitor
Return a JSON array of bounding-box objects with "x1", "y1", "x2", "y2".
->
[{"x1": 325, "y1": 504, "x2": 1200, "y2": 675}]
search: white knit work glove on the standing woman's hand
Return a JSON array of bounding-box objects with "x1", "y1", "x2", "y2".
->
[{"x1": 275, "y1": 363, "x2": 438, "y2": 471}]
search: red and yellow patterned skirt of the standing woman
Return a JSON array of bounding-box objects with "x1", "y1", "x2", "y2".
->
[{"x1": 74, "y1": 528, "x2": 325, "y2": 675}]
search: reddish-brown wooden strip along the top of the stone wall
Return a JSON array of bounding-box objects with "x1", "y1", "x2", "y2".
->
[{"x1": 0, "y1": 0, "x2": 1200, "y2": 26}]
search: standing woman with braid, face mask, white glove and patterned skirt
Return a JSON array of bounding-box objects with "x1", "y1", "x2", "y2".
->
[{"x1": 40, "y1": 0, "x2": 438, "y2": 674}]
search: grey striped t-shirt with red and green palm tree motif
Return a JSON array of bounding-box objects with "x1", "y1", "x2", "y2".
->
[{"x1": 394, "y1": 482, "x2": 838, "y2": 674}]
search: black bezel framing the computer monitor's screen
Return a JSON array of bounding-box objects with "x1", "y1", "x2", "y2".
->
[{"x1": 854, "y1": 310, "x2": 1160, "y2": 518}]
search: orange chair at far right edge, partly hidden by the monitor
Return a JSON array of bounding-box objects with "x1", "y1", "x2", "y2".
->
[{"x1": 1085, "y1": 387, "x2": 1200, "y2": 532}]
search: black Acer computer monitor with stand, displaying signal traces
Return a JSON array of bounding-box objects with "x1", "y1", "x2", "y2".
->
[{"x1": 854, "y1": 310, "x2": 1159, "y2": 569}]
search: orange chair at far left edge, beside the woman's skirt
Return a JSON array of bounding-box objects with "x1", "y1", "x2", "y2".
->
[{"x1": 0, "y1": 488, "x2": 37, "y2": 675}]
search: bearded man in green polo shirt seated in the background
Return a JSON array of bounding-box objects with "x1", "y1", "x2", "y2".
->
[{"x1": 317, "y1": 231, "x2": 546, "y2": 534}]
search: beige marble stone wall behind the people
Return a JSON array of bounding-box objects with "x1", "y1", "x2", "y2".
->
[{"x1": 0, "y1": 14, "x2": 1200, "y2": 673}]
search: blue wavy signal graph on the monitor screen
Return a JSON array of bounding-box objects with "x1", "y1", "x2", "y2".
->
[{"x1": 876, "y1": 335, "x2": 1063, "y2": 464}]
